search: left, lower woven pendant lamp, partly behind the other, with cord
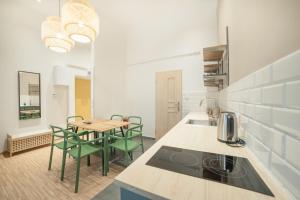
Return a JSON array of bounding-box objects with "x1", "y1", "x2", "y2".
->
[{"x1": 41, "y1": 0, "x2": 75, "y2": 53}]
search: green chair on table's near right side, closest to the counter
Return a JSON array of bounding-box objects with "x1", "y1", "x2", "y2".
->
[{"x1": 109, "y1": 125, "x2": 144, "y2": 165}]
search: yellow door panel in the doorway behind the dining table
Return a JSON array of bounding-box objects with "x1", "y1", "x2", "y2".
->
[{"x1": 75, "y1": 78, "x2": 91, "y2": 119}]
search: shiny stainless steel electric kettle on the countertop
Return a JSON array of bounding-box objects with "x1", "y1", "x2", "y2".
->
[{"x1": 217, "y1": 112, "x2": 239, "y2": 143}]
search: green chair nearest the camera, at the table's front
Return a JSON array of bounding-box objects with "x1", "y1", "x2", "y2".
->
[{"x1": 62, "y1": 129, "x2": 107, "y2": 193}]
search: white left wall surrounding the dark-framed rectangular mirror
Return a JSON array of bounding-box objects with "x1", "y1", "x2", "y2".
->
[{"x1": 0, "y1": 0, "x2": 92, "y2": 152}]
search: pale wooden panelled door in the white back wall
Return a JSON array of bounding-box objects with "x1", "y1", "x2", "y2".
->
[{"x1": 155, "y1": 70, "x2": 182, "y2": 140}]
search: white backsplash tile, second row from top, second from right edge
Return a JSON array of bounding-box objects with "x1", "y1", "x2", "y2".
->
[{"x1": 262, "y1": 84, "x2": 284, "y2": 106}]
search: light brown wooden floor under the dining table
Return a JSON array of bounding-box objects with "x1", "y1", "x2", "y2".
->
[{"x1": 0, "y1": 147, "x2": 124, "y2": 200}]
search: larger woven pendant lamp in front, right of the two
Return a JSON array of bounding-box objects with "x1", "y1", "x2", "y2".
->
[{"x1": 62, "y1": 0, "x2": 99, "y2": 43}]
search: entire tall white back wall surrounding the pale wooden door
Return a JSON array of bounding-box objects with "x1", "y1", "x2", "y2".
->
[{"x1": 125, "y1": 0, "x2": 217, "y2": 137}]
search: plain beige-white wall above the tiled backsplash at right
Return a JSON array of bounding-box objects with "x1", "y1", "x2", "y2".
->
[{"x1": 218, "y1": 0, "x2": 300, "y2": 83}]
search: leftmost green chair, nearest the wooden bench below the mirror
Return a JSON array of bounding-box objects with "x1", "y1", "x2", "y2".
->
[{"x1": 48, "y1": 125, "x2": 86, "y2": 181}]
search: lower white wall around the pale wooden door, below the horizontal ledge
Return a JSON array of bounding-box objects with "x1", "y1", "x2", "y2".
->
[{"x1": 126, "y1": 54, "x2": 205, "y2": 137}]
